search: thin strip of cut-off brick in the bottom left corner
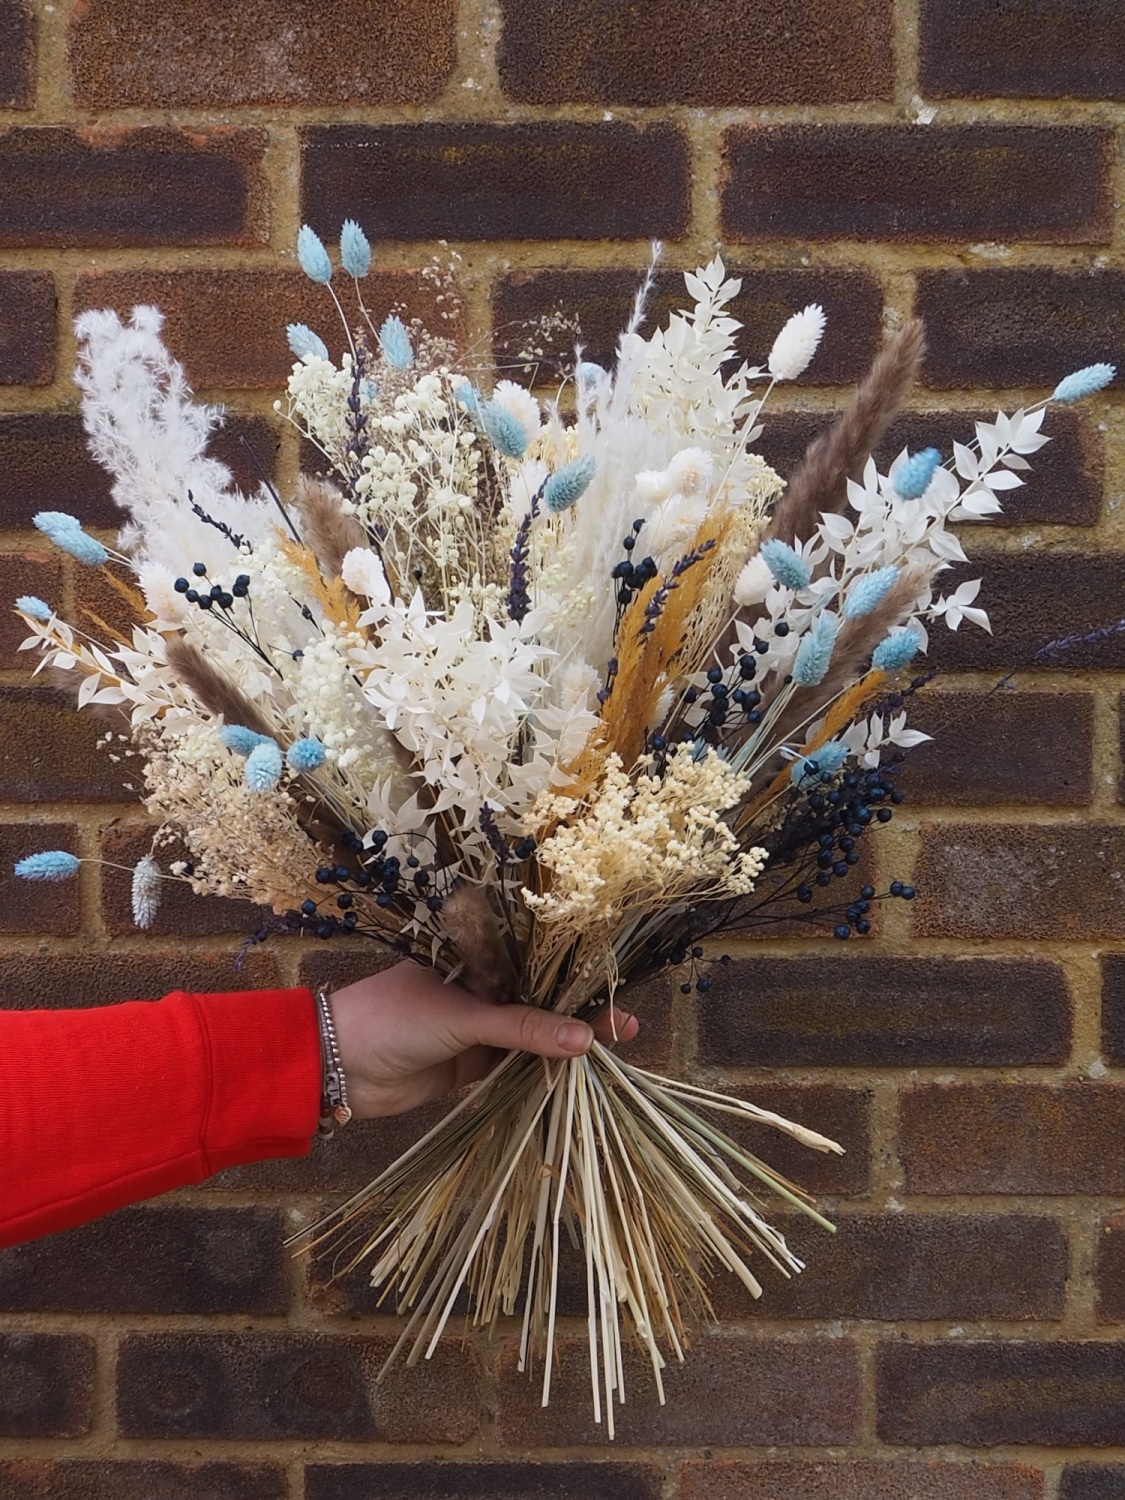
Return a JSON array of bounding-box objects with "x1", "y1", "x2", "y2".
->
[{"x1": 0, "y1": 1458, "x2": 290, "y2": 1500}]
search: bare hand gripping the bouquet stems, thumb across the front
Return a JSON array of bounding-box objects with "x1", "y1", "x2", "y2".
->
[{"x1": 332, "y1": 962, "x2": 638, "y2": 1119}]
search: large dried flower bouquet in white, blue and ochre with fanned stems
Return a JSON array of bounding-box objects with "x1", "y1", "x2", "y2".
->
[{"x1": 17, "y1": 222, "x2": 1113, "y2": 1434}]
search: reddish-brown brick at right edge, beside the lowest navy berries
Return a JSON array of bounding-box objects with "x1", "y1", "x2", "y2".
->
[{"x1": 914, "y1": 824, "x2": 1125, "y2": 942}]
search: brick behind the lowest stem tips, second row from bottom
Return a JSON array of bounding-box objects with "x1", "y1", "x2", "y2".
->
[{"x1": 497, "y1": 1337, "x2": 860, "y2": 1449}]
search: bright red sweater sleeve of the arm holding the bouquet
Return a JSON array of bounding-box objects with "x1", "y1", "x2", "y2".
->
[{"x1": 0, "y1": 990, "x2": 320, "y2": 1245}]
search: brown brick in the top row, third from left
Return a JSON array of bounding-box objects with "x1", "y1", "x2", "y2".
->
[{"x1": 500, "y1": 0, "x2": 894, "y2": 105}]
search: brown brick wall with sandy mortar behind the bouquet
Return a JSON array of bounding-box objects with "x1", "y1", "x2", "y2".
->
[{"x1": 0, "y1": 0, "x2": 1125, "y2": 1500}]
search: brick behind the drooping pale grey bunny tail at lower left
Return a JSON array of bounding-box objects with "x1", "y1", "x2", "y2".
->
[{"x1": 102, "y1": 828, "x2": 267, "y2": 938}]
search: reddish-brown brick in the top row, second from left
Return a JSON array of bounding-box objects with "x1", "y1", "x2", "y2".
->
[{"x1": 69, "y1": 0, "x2": 456, "y2": 110}]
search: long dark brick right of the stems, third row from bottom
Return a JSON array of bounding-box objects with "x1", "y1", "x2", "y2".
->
[{"x1": 716, "y1": 1214, "x2": 1067, "y2": 1323}]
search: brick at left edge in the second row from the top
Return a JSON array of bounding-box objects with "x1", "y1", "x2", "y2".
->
[{"x1": 0, "y1": 126, "x2": 269, "y2": 249}]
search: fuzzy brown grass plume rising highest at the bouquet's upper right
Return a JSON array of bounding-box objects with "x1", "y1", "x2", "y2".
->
[{"x1": 768, "y1": 318, "x2": 926, "y2": 546}]
